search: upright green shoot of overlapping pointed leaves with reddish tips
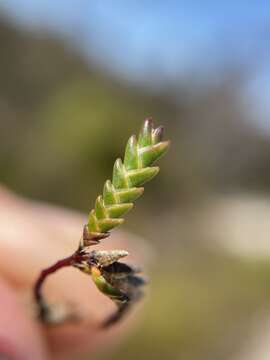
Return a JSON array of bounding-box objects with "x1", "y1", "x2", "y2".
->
[{"x1": 84, "y1": 119, "x2": 169, "y2": 246}]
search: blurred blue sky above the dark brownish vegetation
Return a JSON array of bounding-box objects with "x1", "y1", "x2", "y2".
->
[{"x1": 0, "y1": 0, "x2": 270, "y2": 128}]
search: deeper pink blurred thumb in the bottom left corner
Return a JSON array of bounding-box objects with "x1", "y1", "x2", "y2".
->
[{"x1": 0, "y1": 279, "x2": 47, "y2": 360}]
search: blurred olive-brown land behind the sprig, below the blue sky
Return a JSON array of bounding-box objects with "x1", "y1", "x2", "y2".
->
[{"x1": 0, "y1": 6, "x2": 270, "y2": 360}]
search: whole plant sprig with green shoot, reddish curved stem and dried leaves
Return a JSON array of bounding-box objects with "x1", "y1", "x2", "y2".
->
[{"x1": 34, "y1": 119, "x2": 169, "y2": 327}]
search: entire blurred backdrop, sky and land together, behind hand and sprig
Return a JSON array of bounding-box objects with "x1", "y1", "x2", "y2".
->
[{"x1": 0, "y1": 0, "x2": 270, "y2": 360}]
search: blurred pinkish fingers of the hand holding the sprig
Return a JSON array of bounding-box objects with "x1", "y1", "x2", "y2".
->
[{"x1": 0, "y1": 187, "x2": 144, "y2": 360}]
